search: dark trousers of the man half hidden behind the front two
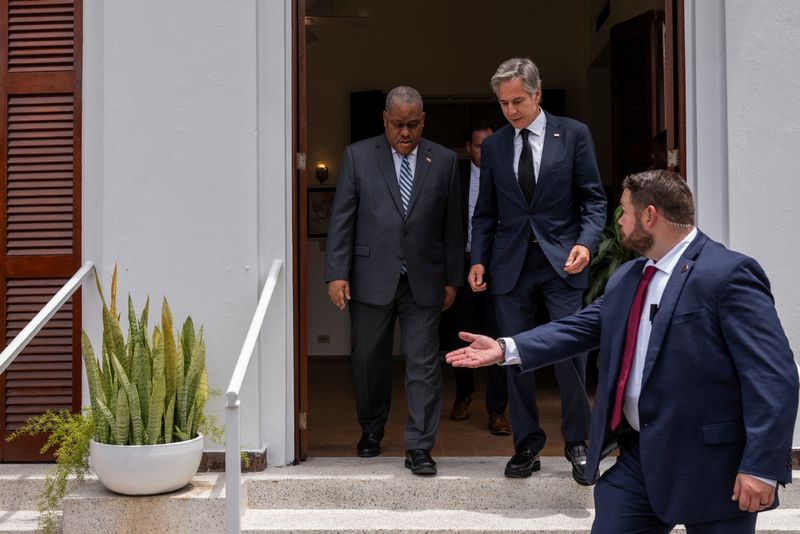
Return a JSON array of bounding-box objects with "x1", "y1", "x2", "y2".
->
[{"x1": 439, "y1": 257, "x2": 508, "y2": 413}]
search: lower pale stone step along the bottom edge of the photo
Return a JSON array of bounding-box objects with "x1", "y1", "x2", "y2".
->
[{"x1": 242, "y1": 509, "x2": 800, "y2": 534}]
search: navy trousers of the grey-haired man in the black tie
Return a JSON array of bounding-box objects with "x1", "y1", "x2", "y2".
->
[{"x1": 495, "y1": 245, "x2": 590, "y2": 452}]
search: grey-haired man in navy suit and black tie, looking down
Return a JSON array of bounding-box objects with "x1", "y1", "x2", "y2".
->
[{"x1": 468, "y1": 58, "x2": 606, "y2": 478}]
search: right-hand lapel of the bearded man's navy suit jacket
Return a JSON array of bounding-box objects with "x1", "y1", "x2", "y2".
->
[{"x1": 642, "y1": 232, "x2": 708, "y2": 388}]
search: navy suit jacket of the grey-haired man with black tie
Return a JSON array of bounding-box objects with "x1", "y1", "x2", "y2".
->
[{"x1": 472, "y1": 111, "x2": 606, "y2": 295}]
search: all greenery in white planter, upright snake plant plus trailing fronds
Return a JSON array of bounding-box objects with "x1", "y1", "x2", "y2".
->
[{"x1": 7, "y1": 267, "x2": 224, "y2": 534}]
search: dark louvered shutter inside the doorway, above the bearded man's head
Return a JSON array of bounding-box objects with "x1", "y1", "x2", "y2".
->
[{"x1": 609, "y1": 11, "x2": 664, "y2": 203}]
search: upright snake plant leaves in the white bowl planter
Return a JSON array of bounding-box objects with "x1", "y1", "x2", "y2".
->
[{"x1": 83, "y1": 268, "x2": 208, "y2": 445}]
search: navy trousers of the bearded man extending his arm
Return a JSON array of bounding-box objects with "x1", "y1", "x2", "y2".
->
[{"x1": 592, "y1": 432, "x2": 757, "y2": 534}]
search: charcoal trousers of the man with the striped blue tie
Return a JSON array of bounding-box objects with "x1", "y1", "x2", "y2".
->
[{"x1": 350, "y1": 276, "x2": 444, "y2": 450}]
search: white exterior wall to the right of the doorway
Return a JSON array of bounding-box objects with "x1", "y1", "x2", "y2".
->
[{"x1": 686, "y1": 0, "x2": 800, "y2": 448}]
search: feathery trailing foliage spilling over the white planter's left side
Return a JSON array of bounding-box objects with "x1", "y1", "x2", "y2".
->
[{"x1": 7, "y1": 408, "x2": 95, "y2": 534}]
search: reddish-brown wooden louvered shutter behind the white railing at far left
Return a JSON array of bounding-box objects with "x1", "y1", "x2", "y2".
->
[{"x1": 0, "y1": 0, "x2": 82, "y2": 462}]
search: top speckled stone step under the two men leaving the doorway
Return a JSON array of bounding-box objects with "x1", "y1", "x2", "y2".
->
[{"x1": 248, "y1": 457, "x2": 610, "y2": 510}]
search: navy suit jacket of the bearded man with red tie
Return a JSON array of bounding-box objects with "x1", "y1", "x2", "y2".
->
[{"x1": 513, "y1": 232, "x2": 798, "y2": 523}]
